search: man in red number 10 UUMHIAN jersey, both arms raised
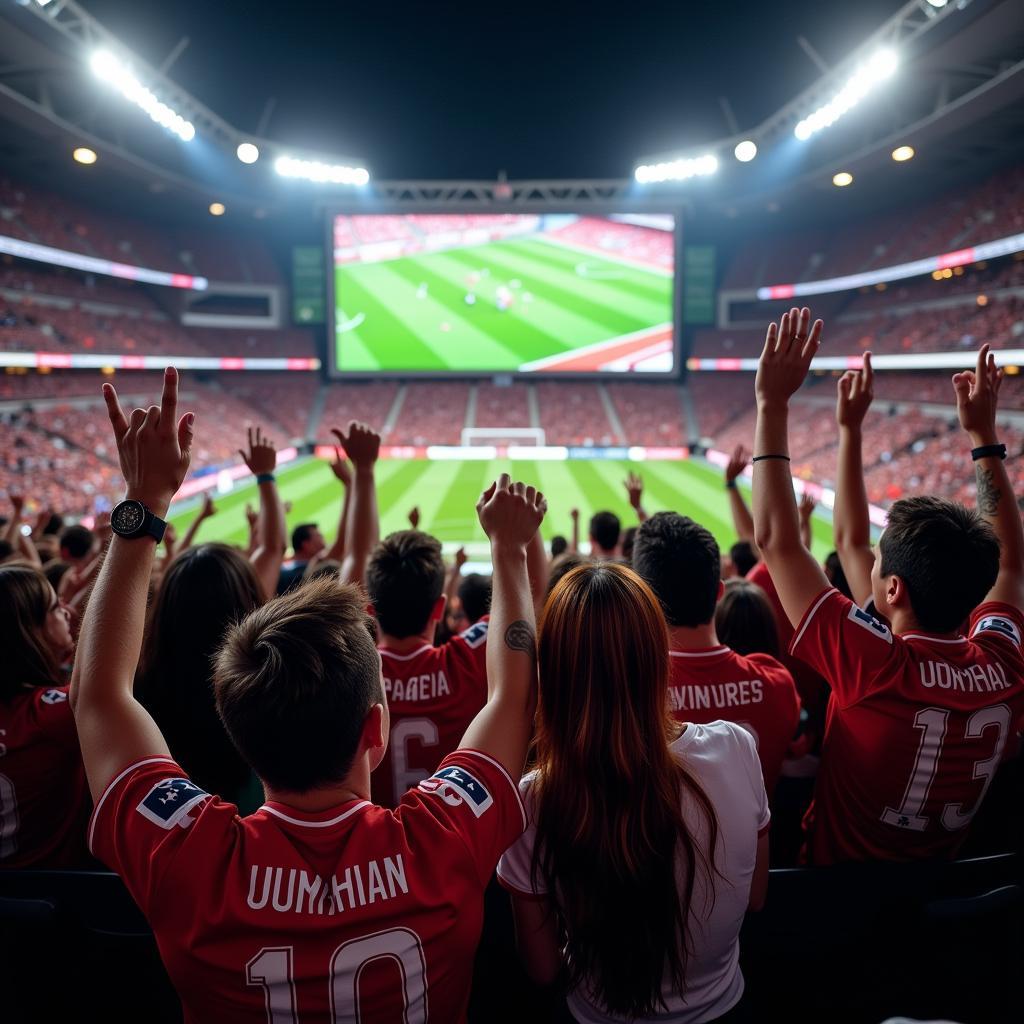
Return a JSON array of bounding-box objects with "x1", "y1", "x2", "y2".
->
[{"x1": 71, "y1": 370, "x2": 546, "y2": 1024}]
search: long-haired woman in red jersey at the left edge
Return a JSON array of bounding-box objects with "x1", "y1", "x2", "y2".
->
[{"x1": 0, "y1": 564, "x2": 91, "y2": 868}]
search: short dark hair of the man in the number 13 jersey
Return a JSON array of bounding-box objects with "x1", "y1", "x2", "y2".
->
[{"x1": 879, "y1": 497, "x2": 999, "y2": 633}]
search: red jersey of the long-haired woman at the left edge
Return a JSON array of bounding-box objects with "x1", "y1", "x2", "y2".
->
[{"x1": 0, "y1": 686, "x2": 91, "y2": 868}]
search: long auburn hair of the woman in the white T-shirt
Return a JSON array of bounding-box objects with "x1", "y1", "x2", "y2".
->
[{"x1": 532, "y1": 562, "x2": 718, "y2": 1017}]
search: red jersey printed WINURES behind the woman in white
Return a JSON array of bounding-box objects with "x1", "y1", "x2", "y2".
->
[{"x1": 669, "y1": 644, "x2": 800, "y2": 797}]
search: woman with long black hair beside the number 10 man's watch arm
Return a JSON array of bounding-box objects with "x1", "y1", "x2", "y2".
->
[{"x1": 135, "y1": 544, "x2": 263, "y2": 814}]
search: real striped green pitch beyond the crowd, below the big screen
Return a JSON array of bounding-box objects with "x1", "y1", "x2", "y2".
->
[{"x1": 171, "y1": 458, "x2": 831, "y2": 558}]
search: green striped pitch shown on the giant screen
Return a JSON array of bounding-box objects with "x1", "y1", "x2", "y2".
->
[{"x1": 335, "y1": 238, "x2": 673, "y2": 372}]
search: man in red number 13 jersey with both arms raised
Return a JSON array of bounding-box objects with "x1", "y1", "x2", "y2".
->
[{"x1": 754, "y1": 309, "x2": 1024, "y2": 864}]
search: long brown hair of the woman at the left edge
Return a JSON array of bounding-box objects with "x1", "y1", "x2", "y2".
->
[{"x1": 0, "y1": 565, "x2": 61, "y2": 702}]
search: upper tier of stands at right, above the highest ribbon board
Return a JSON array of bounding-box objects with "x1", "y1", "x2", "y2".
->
[{"x1": 722, "y1": 167, "x2": 1024, "y2": 290}]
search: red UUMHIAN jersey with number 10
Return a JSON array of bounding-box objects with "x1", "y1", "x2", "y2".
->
[{"x1": 89, "y1": 750, "x2": 526, "y2": 1024}]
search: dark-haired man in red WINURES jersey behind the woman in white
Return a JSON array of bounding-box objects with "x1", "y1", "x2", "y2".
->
[{"x1": 633, "y1": 512, "x2": 800, "y2": 797}]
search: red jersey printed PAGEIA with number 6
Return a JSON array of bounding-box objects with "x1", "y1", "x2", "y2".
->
[{"x1": 370, "y1": 618, "x2": 487, "y2": 807}]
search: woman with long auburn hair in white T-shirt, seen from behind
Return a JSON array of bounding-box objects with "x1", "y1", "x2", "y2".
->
[{"x1": 498, "y1": 562, "x2": 768, "y2": 1022}]
